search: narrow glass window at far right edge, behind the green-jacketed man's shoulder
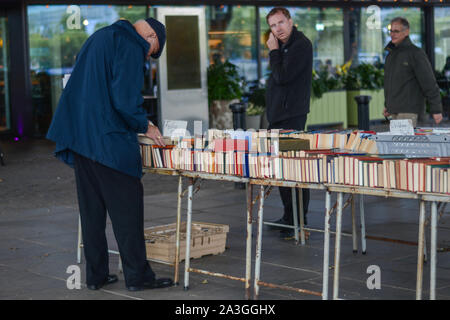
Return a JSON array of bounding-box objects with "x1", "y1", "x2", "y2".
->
[{"x1": 434, "y1": 8, "x2": 450, "y2": 74}]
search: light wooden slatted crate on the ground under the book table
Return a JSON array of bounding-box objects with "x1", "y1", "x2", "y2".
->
[{"x1": 144, "y1": 222, "x2": 229, "y2": 263}]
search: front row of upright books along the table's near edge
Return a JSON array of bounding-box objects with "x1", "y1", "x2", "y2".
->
[{"x1": 141, "y1": 139, "x2": 450, "y2": 194}]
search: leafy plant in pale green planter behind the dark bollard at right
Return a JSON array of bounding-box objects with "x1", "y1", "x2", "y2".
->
[{"x1": 343, "y1": 63, "x2": 384, "y2": 126}]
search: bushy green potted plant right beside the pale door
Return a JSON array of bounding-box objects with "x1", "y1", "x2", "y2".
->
[{"x1": 207, "y1": 60, "x2": 242, "y2": 129}]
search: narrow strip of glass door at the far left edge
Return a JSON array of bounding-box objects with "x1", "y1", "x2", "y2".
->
[{"x1": 0, "y1": 16, "x2": 11, "y2": 132}]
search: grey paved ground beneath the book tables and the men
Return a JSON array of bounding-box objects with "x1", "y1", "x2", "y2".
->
[{"x1": 0, "y1": 135, "x2": 450, "y2": 301}]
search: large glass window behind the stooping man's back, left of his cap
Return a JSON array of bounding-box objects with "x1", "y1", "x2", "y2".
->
[{"x1": 28, "y1": 5, "x2": 148, "y2": 134}]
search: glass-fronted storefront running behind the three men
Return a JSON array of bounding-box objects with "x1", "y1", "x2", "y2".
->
[{"x1": 0, "y1": 0, "x2": 450, "y2": 136}]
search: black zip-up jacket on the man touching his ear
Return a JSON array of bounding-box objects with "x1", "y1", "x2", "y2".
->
[{"x1": 266, "y1": 26, "x2": 313, "y2": 124}]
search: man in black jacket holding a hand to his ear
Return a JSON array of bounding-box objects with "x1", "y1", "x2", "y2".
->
[{"x1": 266, "y1": 7, "x2": 313, "y2": 237}]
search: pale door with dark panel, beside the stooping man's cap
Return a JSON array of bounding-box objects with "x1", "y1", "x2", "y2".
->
[{"x1": 157, "y1": 7, "x2": 209, "y2": 134}]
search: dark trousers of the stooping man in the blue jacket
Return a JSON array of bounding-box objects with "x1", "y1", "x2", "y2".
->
[{"x1": 74, "y1": 154, "x2": 155, "y2": 286}]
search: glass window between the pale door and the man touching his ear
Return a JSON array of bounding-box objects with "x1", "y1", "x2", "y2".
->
[{"x1": 206, "y1": 5, "x2": 258, "y2": 81}]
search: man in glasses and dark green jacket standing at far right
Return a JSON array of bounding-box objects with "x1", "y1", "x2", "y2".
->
[{"x1": 383, "y1": 17, "x2": 442, "y2": 127}]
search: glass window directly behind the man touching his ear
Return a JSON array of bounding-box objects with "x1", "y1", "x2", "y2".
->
[{"x1": 260, "y1": 7, "x2": 344, "y2": 77}]
